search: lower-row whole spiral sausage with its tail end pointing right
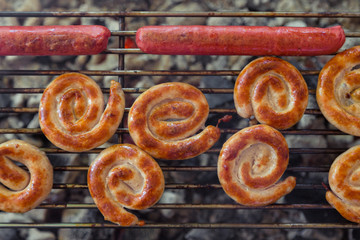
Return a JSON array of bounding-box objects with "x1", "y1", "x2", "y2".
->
[{"x1": 218, "y1": 125, "x2": 296, "y2": 206}]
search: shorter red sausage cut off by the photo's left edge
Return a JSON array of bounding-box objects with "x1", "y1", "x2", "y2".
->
[{"x1": 0, "y1": 25, "x2": 111, "y2": 56}]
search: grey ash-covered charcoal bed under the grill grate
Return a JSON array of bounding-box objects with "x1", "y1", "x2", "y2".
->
[{"x1": 0, "y1": 0, "x2": 360, "y2": 240}]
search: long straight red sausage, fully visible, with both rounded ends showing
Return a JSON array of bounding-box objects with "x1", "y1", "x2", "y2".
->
[{"x1": 136, "y1": 26, "x2": 345, "y2": 56}]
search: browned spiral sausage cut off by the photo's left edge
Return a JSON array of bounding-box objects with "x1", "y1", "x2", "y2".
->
[{"x1": 0, "y1": 140, "x2": 53, "y2": 213}]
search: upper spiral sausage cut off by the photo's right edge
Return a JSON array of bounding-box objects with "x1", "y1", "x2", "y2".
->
[{"x1": 316, "y1": 46, "x2": 360, "y2": 136}]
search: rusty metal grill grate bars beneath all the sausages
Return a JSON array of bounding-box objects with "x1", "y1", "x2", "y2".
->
[{"x1": 0, "y1": 9, "x2": 360, "y2": 232}]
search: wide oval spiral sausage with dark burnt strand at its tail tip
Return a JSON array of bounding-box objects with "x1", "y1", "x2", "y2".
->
[{"x1": 128, "y1": 82, "x2": 220, "y2": 160}]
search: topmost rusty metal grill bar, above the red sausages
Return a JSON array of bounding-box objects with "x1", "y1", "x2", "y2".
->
[{"x1": 0, "y1": 11, "x2": 360, "y2": 18}]
